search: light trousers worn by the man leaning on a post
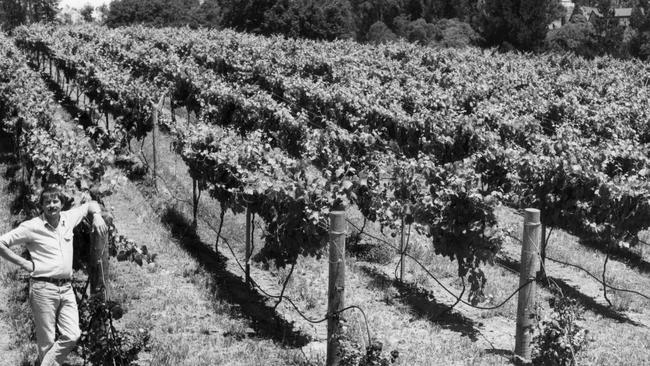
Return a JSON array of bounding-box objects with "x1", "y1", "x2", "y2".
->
[{"x1": 29, "y1": 281, "x2": 81, "y2": 366}]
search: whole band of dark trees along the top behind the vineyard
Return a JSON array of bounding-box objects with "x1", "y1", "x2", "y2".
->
[{"x1": 0, "y1": 0, "x2": 650, "y2": 59}]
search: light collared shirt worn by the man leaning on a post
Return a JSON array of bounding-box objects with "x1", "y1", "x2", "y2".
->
[{"x1": 0, "y1": 203, "x2": 88, "y2": 278}]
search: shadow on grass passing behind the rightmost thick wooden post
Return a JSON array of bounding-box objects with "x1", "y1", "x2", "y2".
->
[{"x1": 496, "y1": 257, "x2": 642, "y2": 326}]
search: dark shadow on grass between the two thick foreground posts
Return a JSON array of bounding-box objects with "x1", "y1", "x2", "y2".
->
[{"x1": 361, "y1": 266, "x2": 479, "y2": 341}]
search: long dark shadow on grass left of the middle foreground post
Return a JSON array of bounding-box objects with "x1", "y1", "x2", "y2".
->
[{"x1": 161, "y1": 207, "x2": 310, "y2": 347}]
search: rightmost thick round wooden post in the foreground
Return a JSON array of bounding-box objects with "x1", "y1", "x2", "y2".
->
[{"x1": 515, "y1": 208, "x2": 541, "y2": 364}]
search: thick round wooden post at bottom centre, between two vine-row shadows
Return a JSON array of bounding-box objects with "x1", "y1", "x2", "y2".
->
[{"x1": 325, "y1": 211, "x2": 346, "y2": 366}]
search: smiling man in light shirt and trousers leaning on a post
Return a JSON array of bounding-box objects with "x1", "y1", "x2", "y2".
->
[{"x1": 0, "y1": 187, "x2": 108, "y2": 366}]
